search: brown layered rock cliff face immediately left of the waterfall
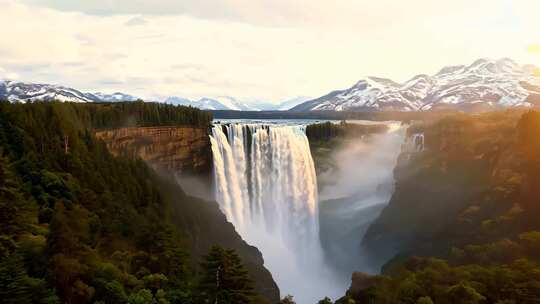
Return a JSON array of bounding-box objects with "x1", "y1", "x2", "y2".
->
[{"x1": 96, "y1": 127, "x2": 212, "y2": 174}]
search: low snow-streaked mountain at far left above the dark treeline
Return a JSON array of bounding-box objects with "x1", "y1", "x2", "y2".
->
[{"x1": 0, "y1": 80, "x2": 138, "y2": 103}]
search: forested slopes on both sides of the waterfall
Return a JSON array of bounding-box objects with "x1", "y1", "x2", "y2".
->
[{"x1": 0, "y1": 102, "x2": 540, "y2": 304}]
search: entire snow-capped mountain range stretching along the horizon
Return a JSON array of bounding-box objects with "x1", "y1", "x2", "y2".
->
[{"x1": 5, "y1": 58, "x2": 540, "y2": 111}]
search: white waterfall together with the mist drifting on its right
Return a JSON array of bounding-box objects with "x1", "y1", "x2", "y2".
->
[{"x1": 208, "y1": 123, "x2": 405, "y2": 304}]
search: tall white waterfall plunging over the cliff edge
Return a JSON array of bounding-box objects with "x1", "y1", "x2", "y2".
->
[{"x1": 210, "y1": 124, "x2": 340, "y2": 304}]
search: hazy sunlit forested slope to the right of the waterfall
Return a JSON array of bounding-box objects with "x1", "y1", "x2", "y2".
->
[{"x1": 336, "y1": 111, "x2": 540, "y2": 304}]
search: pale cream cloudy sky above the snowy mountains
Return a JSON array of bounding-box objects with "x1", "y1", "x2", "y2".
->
[{"x1": 0, "y1": 0, "x2": 540, "y2": 102}]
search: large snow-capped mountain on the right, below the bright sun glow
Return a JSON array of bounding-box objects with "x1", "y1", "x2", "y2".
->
[{"x1": 291, "y1": 58, "x2": 540, "y2": 111}]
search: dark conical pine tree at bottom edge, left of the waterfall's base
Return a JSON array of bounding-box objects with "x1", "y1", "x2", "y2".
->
[{"x1": 200, "y1": 246, "x2": 256, "y2": 304}]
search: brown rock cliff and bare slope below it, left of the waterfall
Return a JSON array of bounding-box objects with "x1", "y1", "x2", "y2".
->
[{"x1": 95, "y1": 126, "x2": 280, "y2": 303}]
